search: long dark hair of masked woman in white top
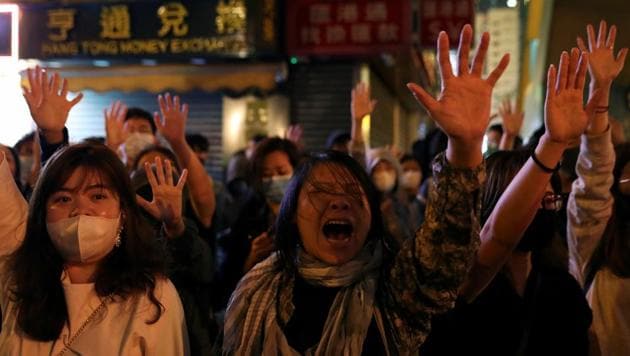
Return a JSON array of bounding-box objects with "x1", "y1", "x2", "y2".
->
[{"x1": 7, "y1": 144, "x2": 166, "y2": 341}]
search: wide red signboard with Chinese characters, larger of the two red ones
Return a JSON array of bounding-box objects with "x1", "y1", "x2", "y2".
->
[{"x1": 286, "y1": 0, "x2": 411, "y2": 55}]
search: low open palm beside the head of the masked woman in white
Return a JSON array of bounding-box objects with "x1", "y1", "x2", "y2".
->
[{"x1": 136, "y1": 157, "x2": 188, "y2": 237}]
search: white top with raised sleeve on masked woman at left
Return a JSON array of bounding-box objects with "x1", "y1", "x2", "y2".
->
[{"x1": 0, "y1": 154, "x2": 190, "y2": 356}]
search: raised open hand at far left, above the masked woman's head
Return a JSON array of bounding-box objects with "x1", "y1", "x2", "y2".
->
[{"x1": 22, "y1": 66, "x2": 83, "y2": 133}]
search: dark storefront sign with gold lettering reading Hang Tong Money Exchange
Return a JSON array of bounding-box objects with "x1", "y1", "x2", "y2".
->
[{"x1": 20, "y1": 0, "x2": 277, "y2": 59}]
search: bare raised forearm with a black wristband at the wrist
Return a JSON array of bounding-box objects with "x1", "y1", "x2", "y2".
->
[{"x1": 460, "y1": 136, "x2": 566, "y2": 300}]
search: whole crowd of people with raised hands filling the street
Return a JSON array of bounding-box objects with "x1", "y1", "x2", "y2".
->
[{"x1": 0, "y1": 21, "x2": 630, "y2": 355}]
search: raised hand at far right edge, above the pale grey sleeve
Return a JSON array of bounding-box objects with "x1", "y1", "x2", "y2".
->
[{"x1": 577, "y1": 20, "x2": 628, "y2": 88}]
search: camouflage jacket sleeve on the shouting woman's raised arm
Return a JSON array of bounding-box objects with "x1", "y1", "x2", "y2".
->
[{"x1": 376, "y1": 153, "x2": 485, "y2": 354}]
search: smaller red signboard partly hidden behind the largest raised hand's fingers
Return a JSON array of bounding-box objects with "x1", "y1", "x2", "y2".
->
[{"x1": 420, "y1": 0, "x2": 475, "y2": 47}]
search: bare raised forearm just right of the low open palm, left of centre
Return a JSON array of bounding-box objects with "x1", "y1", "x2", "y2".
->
[{"x1": 171, "y1": 141, "x2": 216, "y2": 227}]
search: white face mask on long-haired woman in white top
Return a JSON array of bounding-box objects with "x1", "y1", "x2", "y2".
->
[{"x1": 46, "y1": 215, "x2": 120, "y2": 263}]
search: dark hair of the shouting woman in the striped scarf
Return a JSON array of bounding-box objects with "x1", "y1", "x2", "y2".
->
[{"x1": 275, "y1": 150, "x2": 384, "y2": 271}]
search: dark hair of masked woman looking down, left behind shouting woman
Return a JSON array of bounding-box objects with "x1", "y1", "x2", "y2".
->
[{"x1": 250, "y1": 137, "x2": 300, "y2": 192}]
